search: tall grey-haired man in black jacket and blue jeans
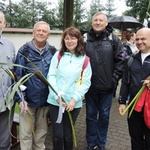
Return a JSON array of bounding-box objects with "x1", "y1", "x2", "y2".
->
[{"x1": 85, "y1": 12, "x2": 124, "y2": 150}]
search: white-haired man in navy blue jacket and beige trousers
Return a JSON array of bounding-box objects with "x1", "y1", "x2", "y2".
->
[{"x1": 15, "y1": 21, "x2": 56, "y2": 150}]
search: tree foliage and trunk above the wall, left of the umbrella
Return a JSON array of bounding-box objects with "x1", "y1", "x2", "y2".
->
[{"x1": 0, "y1": 0, "x2": 114, "y2": 32}]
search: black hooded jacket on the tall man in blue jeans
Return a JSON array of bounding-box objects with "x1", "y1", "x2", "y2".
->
[{"x1": 85, "y1": 25, "x2": 124, "y2": 93}]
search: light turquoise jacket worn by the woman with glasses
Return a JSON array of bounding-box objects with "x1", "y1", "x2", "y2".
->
[{"x1": 47, "y1": 52, "x2": 92, "y2": 108}]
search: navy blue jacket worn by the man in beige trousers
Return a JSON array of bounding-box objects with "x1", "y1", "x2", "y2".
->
[{"x1": 15, "y1": 41, "x2": 56, "y2": 108}]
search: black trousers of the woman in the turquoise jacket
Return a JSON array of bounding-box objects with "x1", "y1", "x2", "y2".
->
[{"x1": 50, "y1": 105, "x2": 81, "y2": 150}]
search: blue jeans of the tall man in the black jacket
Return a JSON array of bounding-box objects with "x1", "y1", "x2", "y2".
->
[{"x1": 85, "y1": 93, "x2": 113, "y2": 147}]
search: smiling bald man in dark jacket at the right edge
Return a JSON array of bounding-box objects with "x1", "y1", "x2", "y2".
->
[{"x1": 119, "y1": 28, "x2": 150, "y2": 150}]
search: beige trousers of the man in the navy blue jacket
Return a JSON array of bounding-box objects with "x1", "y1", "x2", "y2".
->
[{"x1": 19, "y1": 106, "x2": 49, "y2": 150}]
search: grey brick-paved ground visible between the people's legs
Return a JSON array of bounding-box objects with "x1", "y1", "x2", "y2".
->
[{"x1": 13, "y1": 84, "x2": 131, "y2": 150}]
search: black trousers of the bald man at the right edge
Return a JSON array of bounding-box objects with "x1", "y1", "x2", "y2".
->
[{"x1": 128, "y1": 110, "x2": 150, "y2": 150}]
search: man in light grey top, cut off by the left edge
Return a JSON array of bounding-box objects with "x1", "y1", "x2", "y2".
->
[{"x1": 0, "y1": 11, "x2": 15, "y2": 150}]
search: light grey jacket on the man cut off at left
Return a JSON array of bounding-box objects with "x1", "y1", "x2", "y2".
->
[{"x1": 0, "y1": 37, "x2": 15, "y2": 112}]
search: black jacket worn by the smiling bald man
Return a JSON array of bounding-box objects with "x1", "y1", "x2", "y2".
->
[{"x1": 119, "y1": 52, "x2": 150, "y2": 104}]
